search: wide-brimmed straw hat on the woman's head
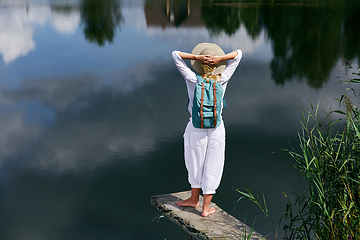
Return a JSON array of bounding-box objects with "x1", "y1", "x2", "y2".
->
[{"x1": 191, "y1": 43, "x2": 226, "y2": 75}]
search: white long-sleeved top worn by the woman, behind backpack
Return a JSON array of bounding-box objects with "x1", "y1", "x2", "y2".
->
[{"x1": 172, "y1": 49, "x2": 242, "y2": 114}]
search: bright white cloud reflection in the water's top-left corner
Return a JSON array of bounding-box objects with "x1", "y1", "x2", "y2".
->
[{"x1": 0, "y1": 5, "x2": 80, "y2": 65}]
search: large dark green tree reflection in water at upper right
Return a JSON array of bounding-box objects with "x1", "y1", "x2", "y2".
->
[{"x1": 201, "y1": 0, "x2": 360, "y2": 89}]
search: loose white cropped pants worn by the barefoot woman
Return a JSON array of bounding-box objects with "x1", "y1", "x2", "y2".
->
[{"x1": 184, "y1": 119, "x2": 225, "y2": 194}]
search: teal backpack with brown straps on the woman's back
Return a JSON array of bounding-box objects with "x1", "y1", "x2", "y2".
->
[{"x1": 192, "y1": 75, "x2": 224, "y2": 128}]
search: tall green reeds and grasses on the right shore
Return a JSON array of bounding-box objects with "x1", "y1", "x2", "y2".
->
[{"x1": 236, "y1": 61, "x2": 360, "y2": 240}]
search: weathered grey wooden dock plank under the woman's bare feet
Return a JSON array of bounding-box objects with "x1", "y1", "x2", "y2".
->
[{"x1": 151, "y1": 191, "x2": 265, "y2": 240}]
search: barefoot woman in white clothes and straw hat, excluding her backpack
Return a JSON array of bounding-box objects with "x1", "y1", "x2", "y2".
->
[{"x1": 172, "y1": 43, "x2": 242, "y2": 217}]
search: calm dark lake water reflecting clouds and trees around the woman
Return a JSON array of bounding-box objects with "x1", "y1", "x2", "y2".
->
[{"x1": 0, "y1": 0, "x2": 360, "y2": 240}]
